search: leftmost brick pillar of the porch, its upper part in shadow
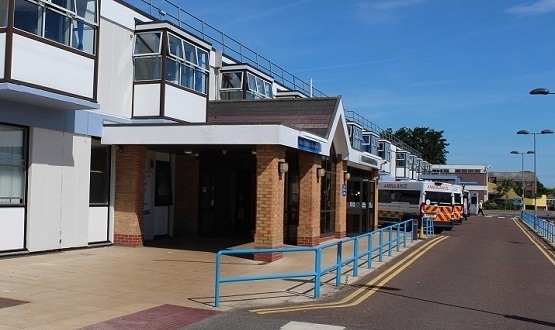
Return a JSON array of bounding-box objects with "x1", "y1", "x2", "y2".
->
[{"x1": 114, "y1": 146, "x2": 146, "y2": 246}]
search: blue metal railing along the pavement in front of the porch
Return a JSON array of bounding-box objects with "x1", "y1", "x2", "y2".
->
[{"x1": 214, "y1": 219, "x2": 433, "y2": 307}]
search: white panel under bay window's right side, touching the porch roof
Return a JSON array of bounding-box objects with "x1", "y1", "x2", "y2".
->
[{"x1": 164, "y1": 85, "x2": 207, "y2": 123}]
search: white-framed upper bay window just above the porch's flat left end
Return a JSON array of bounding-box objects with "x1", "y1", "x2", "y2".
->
[{"x1": 133, "y1": 31, "x2": 210, "y2": 94}]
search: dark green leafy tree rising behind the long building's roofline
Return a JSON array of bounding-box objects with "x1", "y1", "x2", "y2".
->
[{"x1": 386, "y1": 127, "x2": 449, "y2": 164}]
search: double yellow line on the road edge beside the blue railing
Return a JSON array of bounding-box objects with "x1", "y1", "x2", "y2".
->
[{"x1": 250, "y1": 236, "x2": 447, "y2": 314}]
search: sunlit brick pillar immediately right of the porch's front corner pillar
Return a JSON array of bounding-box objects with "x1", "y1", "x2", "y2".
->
[{"x1": 297, "y1": 152, "x2": 321, "y2": 246}]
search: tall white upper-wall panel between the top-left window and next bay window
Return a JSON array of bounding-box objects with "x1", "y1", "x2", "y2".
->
[{"x1": 98, "y1": 17, "x2": 133, "y2": 118}]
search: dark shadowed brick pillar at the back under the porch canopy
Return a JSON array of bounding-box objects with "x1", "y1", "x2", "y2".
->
[{"x1": 174, "y1": 155, "x2": 199, "y2": 237}]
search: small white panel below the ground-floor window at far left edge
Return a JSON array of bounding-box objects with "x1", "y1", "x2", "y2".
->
[{"x1": 0, "y1": 207, "x2": 25, "y2": 251}]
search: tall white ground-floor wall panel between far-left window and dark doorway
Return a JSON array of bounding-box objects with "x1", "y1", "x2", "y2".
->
[{"x1": 27, "y1": 128, "x2": 90, "y2": 252}]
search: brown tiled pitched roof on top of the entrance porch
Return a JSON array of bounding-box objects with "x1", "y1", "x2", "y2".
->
[{"x1": 206, "y1": 97, "x2": 340, "y2": 138}]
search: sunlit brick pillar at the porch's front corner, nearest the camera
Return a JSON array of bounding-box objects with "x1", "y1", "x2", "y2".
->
[{"x1": 254, "y1": 145, "x2": 285, "y2": 262}]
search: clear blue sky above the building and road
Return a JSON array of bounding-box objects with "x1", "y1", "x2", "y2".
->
[{"x1": 168, "y1": 0, "x2": 555, "y2": 188}]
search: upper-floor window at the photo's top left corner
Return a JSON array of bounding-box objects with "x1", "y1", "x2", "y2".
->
[{"x1": 13, "y1": 0, "x2": 98, "y2": 54}]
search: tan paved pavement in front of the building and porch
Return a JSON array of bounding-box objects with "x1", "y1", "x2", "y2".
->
[{"x1": 0, "y1": 235, "x2": 421, "y2": 330}]
